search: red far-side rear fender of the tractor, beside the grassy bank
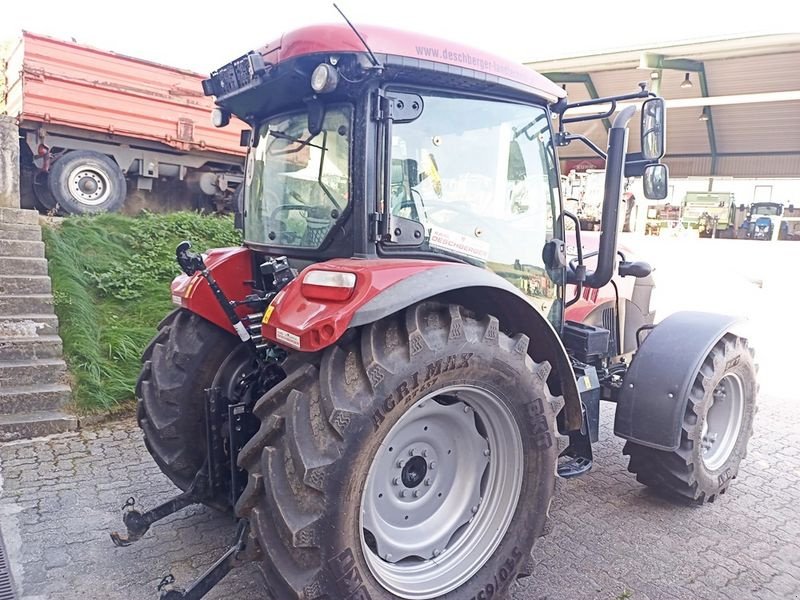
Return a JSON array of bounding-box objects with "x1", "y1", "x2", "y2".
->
[{"x1": 172, "y1": 247, "x2": 253, "y2": 334}]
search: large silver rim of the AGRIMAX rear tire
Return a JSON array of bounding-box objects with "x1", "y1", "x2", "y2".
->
[{"x1": 361, "y1": 386, "x2": 524, "y2": 600}]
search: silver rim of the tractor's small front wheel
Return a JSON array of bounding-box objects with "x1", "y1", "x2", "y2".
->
[{"x1": 700, "y1": 373, "x2": 744, "y2": 471}]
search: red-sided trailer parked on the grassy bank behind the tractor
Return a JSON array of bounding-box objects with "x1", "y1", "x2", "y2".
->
[{"x1": 0, "y1": 32, "x2": 244, "y2": 214}]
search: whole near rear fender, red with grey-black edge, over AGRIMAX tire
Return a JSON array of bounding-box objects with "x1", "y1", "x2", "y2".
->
[{"x1": 262, "y1": 259, "x2": 582, "y2": 429}]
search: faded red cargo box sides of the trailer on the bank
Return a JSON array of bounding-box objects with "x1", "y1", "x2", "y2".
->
[{"x1": 5, "y1": 32, "x2": 246, "y2": 156}]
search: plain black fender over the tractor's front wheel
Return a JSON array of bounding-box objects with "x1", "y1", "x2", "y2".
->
[{"x1": 614, "y1": 312, "x2": 742, "y2": 452}]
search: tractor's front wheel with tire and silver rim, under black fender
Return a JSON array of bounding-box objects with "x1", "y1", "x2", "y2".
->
[{"x1": 623, "y1": 334, "x2": 758, "y2": 504}]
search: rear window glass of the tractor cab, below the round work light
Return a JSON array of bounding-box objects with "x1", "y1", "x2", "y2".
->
[{"x1": 245, "y1": 107, "x2": 351, "y2": 248}]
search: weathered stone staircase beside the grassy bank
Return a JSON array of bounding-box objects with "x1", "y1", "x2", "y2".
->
[{"x1": 0, "y1": 208, "x2": 78, "y2": 441}]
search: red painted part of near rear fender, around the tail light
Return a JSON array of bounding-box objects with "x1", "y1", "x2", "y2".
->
[{"x1": 261, "y1": 258, "x2": 460, "y2": 352}]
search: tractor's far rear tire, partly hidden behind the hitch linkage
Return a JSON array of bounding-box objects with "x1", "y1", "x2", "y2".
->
[{"x1": 136, "y1": 309, "x2": 241, "y2": 508}]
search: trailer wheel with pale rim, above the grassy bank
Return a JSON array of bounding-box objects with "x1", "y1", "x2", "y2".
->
[{"x1": 48, "y1": 150, "x2": 127, "y2": 215}]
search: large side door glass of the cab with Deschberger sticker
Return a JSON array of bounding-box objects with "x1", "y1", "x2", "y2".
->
[{"x1": 389, "y1": 95, "x2": 560, "y2": 324}]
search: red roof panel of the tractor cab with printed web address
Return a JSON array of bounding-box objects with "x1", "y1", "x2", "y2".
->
[{"x1": 260, "y1": 24, "x2": 566, "y2": 102}]
